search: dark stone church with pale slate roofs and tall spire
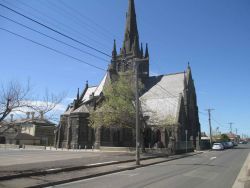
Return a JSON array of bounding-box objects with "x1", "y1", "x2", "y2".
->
[{"x1": 55, "y1": 0, "x2": 200, "y2": 150}]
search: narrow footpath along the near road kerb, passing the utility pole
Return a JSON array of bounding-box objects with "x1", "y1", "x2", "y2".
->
[{"x1": 1, "y1": 152, "x2": 202, "y2": 188}]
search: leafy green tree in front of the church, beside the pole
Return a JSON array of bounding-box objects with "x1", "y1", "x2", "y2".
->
[{"x1": 90, "y1": 72, "x2": 142, "y2": 128}]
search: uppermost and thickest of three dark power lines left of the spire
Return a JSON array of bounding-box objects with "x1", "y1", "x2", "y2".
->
[{"x1": 0, "y1": 3, "x2": 111, "y2": 57}]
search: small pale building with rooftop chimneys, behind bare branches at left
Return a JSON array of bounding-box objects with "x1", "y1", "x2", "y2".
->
[{"x1": 0, "y1": 112, "x2": 56, "y2": 146}]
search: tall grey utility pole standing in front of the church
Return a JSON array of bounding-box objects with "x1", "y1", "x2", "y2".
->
[{"x1": 135, "y1": 60, "x2": 140, "y2": 165}]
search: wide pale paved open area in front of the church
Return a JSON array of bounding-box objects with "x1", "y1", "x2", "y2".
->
[{"x1": 0, "y1": 151, "x2": 166, "y2": 180}]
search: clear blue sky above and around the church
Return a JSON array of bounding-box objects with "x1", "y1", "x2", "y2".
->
[{"x1": 0, "y1": 0, "x2": 250, "y2": 135}]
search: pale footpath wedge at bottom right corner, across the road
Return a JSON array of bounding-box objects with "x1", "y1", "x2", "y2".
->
[{"x1": 232, "y1": 153, "x2": 250, "y2": 188}]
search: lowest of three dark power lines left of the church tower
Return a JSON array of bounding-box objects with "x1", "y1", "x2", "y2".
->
[{"x1": 0, "y1": 27, "x2": 106, "y2": 72}]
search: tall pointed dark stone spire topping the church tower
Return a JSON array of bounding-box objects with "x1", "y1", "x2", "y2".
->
[{"x1": 123, "y1": 0, "x2": 140, "y2": 53}]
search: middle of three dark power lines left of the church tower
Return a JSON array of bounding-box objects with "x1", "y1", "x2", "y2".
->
[{"x1": 0, "y1": 14, "x2": 109, "y2": 62}]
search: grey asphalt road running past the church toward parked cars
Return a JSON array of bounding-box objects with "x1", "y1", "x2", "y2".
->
[{"x1": 58, "y1": 144, "x2": 250, "y2": 188}]
